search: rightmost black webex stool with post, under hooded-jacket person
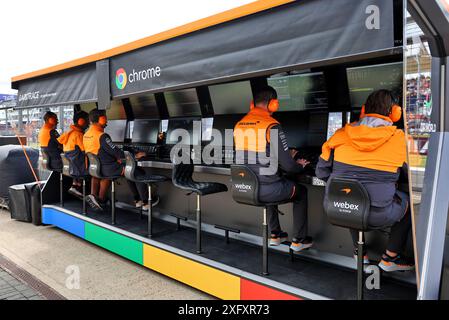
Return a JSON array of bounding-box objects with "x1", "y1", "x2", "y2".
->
[{"x1": 324, "y1": 178, "x2": 371, "y2": 300}]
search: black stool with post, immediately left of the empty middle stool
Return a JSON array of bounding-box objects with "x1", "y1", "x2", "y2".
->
[{"x1": 125, "y1": 151, "x2": 169, "y2": 238}]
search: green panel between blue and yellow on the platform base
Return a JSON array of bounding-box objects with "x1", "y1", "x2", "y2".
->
[{"x1": 85, "y1": 222, "x2": 143, "y2": 265}]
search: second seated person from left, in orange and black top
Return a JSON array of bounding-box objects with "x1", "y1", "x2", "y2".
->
[{"x1": 58, "y1": 111, "x2": 89, "y2": 197}]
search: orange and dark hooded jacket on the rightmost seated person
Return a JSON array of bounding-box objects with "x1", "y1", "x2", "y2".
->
[{"x1": 316, "y1": 114, "x2": 407, "y2": 208}]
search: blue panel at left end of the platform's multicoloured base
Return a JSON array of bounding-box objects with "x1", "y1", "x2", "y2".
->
[{"x1": 42, "y1": 207, "x2": 84, "y2": 239}]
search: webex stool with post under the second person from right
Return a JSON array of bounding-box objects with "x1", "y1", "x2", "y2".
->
[{"x1": 231, "y1": 165, "x2": 291, "y2": 276}]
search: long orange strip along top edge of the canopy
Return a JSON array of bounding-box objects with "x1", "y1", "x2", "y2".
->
[{"x1": 11, "y1": 0, "x2": 294, "y2": 82}]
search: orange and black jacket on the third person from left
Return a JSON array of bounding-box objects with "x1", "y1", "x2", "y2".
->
[{"x1": 83, "y1": 124, "x2": 125, "y2": 177}]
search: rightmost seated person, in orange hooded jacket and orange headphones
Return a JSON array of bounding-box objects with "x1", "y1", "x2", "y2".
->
[{"x1": 316, "y1": 90, "x2": 414, "y2": 272}]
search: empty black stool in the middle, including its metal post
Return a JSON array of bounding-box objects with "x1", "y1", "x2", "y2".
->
[{"x1": 172, "y1": 164, "x2": 228, "y2": 254}]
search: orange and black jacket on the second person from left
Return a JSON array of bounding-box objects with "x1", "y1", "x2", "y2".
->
[{"x1": 58, "y1": 125, "x2": 88, "y2": 177}]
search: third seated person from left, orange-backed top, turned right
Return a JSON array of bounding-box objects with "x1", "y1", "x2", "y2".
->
[{"x1": 83, "y1": 109, "x2": 148, "y2": 211}]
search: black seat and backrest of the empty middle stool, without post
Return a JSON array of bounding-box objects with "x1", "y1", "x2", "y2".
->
[{"x1": 172, "y1": 164, "x2": 228, "y2": 196}]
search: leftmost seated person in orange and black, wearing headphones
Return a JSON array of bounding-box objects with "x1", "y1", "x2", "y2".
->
[{"x1": 39, "y1": 111, "x2": 62, "y2": 169}]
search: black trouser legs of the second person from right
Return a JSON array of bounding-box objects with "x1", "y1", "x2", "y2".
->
[{"x1": 267, "y1": 184, "x2": 308, "y2": 239}]
